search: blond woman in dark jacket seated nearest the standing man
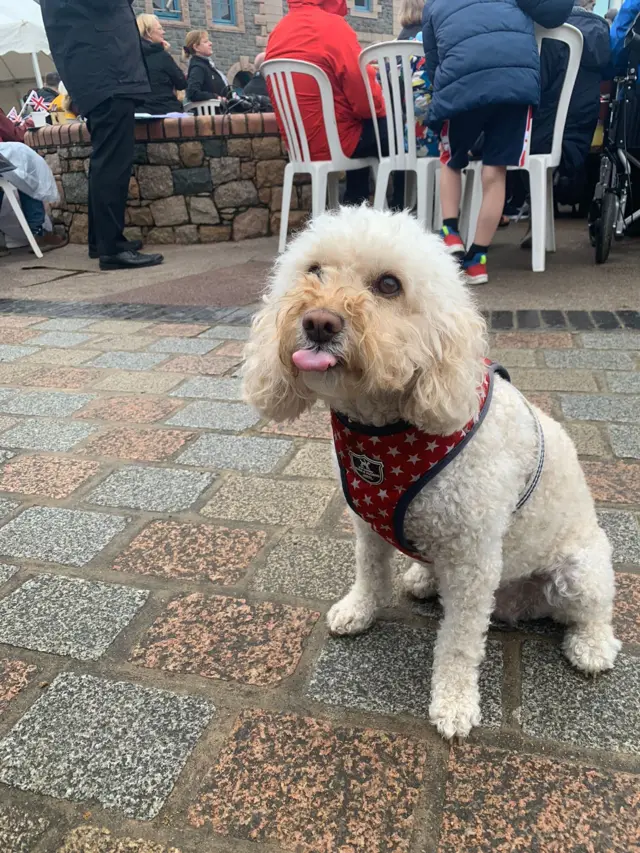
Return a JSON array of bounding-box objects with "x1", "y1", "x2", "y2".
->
[{"x1": 136, "y1": 15, "x2": 187, "y2": 115}]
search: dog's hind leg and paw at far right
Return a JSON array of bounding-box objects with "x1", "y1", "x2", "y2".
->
[{"x1": 547, "y1": 530, "x2": 621, "y2": 673}]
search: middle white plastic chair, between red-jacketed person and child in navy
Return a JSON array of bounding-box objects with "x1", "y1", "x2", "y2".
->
[{"x1": 360, "y1": 41, "x2": 440, "y2": 229}]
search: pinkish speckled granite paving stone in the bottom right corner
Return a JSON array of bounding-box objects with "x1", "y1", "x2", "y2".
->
[{"x1": 438, "y1": 746, "x2": 638, "y2": 853}]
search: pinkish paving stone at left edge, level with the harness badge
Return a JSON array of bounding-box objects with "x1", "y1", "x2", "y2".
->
[{"x1": 0, "y1": 456, "x2": 100, "y2": 500}]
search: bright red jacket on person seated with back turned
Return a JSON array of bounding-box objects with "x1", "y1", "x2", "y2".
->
[{"x1": 266, "y1": 0, "x2": 384, "y2": 160}]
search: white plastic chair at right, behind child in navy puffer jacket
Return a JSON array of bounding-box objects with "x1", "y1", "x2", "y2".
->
[{"x1": 460, "y1": 24, "x2": 583, "y2": 272}]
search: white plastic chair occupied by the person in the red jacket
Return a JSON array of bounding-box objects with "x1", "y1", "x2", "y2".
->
[{"x1": 260, "y1": 59, "x2": 378, "y2": 252}]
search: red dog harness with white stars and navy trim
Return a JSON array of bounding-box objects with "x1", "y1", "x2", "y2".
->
[{"x1": 331, "y1": 363, "x2": 544, "y2": 562}]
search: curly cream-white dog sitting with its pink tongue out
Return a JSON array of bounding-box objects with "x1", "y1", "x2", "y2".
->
[{"x1": 244, "y1": 207, "x2": 620, "y2": 738}]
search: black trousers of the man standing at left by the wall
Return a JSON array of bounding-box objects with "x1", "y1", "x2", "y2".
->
[{"x1": 87, "y1": 97, "x2": 135, "y2": 255}]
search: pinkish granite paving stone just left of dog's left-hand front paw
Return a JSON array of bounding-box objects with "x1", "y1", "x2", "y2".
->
[{"x1": 130, "y1": 593, "x2": 320, "y2": 687}]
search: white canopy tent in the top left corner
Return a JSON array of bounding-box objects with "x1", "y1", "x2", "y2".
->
[{"x1": 0, "y1": 0, "x2": 54, "y2": 111}]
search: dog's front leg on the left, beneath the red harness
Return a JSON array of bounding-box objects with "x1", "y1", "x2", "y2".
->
[{"x1": 327, "y1": 516, "x2": 394, "y2": 634}]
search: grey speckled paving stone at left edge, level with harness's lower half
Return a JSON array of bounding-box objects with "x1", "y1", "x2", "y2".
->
[{"x1": 0, "y1": 506, "x2": 128, "y2": 566}]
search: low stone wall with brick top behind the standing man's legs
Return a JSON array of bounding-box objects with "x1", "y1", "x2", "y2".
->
[{"x1": 25, "y1": 114, "x2": 311, "y2": 244}]
